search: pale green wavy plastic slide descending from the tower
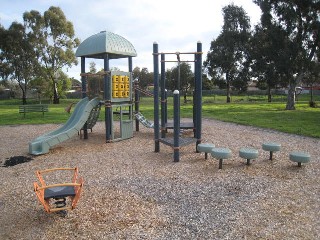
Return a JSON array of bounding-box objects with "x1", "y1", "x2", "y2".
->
[{"x1": 29, "y1": 98, "x2": 99, "y2": 155}]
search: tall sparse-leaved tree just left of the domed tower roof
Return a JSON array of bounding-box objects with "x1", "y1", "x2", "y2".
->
[{"x1": 23, "y1": 6, "x2": 80, "y2": 103}]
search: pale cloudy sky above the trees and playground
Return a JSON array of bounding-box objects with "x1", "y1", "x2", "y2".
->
[{"x1": 0, "y1": 0, "x2": 261, "y2": 79}]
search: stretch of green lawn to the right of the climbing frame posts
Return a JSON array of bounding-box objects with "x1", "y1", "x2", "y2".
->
[{"x1": 203, "y1": 103, "x2": 320, "y2": 137}]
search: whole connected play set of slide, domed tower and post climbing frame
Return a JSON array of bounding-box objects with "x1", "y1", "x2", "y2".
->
[{"x1": 29, "y1": 31, "x2": 202, "y2": 161}]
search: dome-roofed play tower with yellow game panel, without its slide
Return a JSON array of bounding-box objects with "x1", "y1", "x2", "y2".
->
[{"x1": 76, "y1": 31, "x2": 137, "y2": 142}]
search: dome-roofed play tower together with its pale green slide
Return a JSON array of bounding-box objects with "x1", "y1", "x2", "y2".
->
[{"x1": 29, "y1": 31, "x2": 137, "y2": 155}]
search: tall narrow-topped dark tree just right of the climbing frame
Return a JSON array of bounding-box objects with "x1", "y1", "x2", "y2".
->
[{"x1": 204, "y1": 4, "x2": 250, "y2": 102}]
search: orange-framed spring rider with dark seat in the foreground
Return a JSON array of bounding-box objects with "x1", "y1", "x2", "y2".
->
[{"x1": 33, "y1": 168, "x2": 83, "y2": 213}]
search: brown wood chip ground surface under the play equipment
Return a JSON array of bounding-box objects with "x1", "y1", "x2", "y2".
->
[{"x1": 0, "y1": 119, "x2": 320, "y2": 240}]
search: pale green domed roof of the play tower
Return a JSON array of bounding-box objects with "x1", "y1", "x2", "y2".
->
[{"x1": 76, "y1": 31, "x2": 137, "y2": 59}]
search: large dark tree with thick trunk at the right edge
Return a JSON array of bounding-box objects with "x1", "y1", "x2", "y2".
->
[{"x1": 254, "y1": 0, "x2": 320, "y2": 110}]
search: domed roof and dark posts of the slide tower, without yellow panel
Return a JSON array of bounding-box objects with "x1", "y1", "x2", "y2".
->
[{"x1": 76, "y1": 31, "x2": 137, "y2": 142}]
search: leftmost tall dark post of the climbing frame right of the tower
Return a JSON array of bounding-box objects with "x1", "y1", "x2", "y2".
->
[{"x1": 153, "y1": 42, "x2": 160, "y2": 152}]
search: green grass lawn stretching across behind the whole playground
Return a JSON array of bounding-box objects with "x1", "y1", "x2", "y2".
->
[{"x1": 0, "y1": 96, "x2": 320, "y2": 138}]
